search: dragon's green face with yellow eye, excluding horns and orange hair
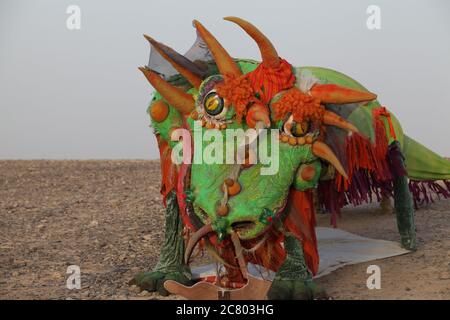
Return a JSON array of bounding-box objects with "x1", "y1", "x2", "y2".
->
[{"x1": 188, "y1": 76, "x2": 320, "y2": 239}]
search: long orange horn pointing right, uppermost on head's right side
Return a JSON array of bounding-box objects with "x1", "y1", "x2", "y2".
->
[{"x1": 310, "y1": 84, "x2": 377, "y2": 104}]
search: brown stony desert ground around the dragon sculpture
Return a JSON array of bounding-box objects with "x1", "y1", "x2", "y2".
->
[{"x1": 0, "y1": 160, "x2": 450, "y2": 299}]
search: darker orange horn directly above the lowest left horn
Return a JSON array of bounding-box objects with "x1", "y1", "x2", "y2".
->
[{"x1": 144, "y1": 34, "x2": 202, "y2": 89}]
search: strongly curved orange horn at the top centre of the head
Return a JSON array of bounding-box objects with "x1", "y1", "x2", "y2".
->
[{"x1": 223, "y1": 17, "x2": 280, "y2": 68}]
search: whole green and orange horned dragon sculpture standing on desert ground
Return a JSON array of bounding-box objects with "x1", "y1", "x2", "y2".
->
[{"x1": 132, "y1": 17, "x2": 450, "y2": 299}]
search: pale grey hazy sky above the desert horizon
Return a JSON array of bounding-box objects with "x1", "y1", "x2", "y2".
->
[{"x1": 0, "y1": 0, "x2": 450, "y2": 159}]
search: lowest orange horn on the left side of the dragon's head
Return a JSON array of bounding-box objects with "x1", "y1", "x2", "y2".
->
[{"x1": 139, "y1": 67, "x2": 195, "y2": 114}]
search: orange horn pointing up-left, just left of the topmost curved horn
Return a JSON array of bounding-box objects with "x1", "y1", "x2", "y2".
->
[{"x1": 193, "y1": 20, "x2": 242, "y2": 76}]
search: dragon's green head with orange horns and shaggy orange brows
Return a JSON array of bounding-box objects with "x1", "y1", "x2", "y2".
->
[{"x1": 140, "y1": 17, "x2": 376, "y2": 264}]
